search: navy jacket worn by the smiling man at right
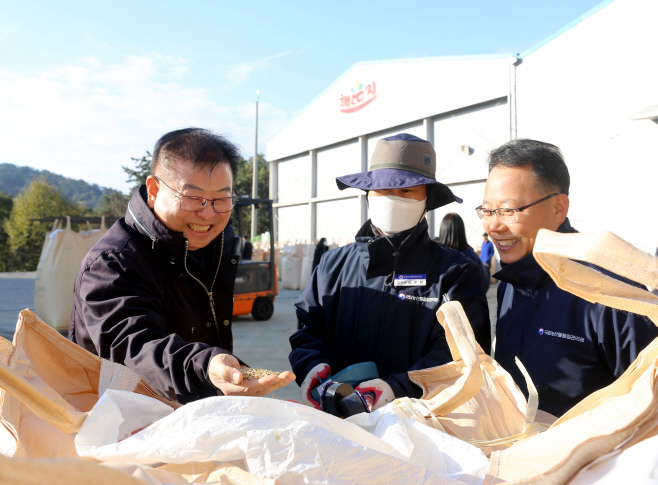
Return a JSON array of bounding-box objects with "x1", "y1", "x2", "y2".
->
[{"x1": 494, "y1": 219, "x2": 658, "y2": 416}]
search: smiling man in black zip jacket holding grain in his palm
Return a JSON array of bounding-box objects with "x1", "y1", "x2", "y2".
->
[{"x1": 69, "y1": 128, "x2": 294, "y2": 403}]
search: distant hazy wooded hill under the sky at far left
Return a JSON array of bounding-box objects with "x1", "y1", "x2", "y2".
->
[{"x1": 0, "y1": 163, "x2": 118, "y2": 209}]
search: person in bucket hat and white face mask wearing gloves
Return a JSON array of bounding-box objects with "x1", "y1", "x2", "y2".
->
[{"x1": 290, "y1": 133, "x2": 491, "y2": 409}]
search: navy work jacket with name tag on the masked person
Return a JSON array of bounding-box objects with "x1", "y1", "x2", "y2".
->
[{"x1": 290, "y1": 219, "x2": 491, "y2": 397}]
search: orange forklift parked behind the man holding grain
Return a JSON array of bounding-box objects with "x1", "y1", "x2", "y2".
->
[{"x1": 233, "y1": 197, "x2": 279, "y2": 320}]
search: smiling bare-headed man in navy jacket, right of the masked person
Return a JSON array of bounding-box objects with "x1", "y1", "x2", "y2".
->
[{"x1": 476, "y1": 140, "x2": 658, "y2": 416}]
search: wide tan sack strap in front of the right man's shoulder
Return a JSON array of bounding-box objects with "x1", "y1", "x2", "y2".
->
[{"x1": 533, "y1": 229, "x2": 658, "y2": 325}]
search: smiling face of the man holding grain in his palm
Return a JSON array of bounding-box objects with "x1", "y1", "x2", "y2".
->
[{"x1": 146, "y1": 161, "x2": 233, "y2": 251}]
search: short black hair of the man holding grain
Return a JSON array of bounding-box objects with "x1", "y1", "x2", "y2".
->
[{"x1": 151, "y1": 128, "x2": 240, "y2": 181}]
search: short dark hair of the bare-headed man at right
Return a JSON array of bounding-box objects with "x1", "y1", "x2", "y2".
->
[{"x1": 489, "y1": 138, "x2": 570, "y2": 195}]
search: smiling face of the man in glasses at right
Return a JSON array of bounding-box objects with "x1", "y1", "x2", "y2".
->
[{"x1": 482, "y1": 165, "x2": 569, "y2": 263}]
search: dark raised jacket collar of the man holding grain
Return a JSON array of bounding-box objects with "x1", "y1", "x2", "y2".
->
[{"x1": 125, "y1": 185, "x2": 185, "y2": 255}]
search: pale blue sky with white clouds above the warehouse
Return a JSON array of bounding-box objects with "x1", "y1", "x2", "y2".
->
[{"x1": 0, "y1": 0, "x2": 600, "y2": 191}]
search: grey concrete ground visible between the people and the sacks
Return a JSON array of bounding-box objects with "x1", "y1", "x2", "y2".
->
[{"x1": 0, "y1": 273, "x2": 496, "y2": 400}]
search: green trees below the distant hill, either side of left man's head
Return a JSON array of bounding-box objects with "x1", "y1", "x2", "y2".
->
[{"x1": 0, "y1": 151, "x2": 269, "y2": 272}]
